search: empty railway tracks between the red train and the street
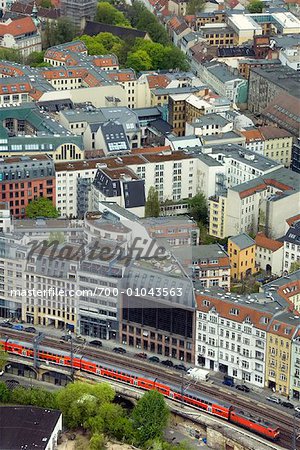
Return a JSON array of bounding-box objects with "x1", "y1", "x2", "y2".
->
[{"x1": 0, "y1": 329, "x2": 300, "y2": 449}]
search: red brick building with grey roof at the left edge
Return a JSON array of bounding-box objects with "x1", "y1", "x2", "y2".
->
[{"x1": 0, "y1": 155, "x2": 56, "y2": 219}]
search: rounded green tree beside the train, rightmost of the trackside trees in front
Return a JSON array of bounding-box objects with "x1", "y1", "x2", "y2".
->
[{"x1": 132, "y1": 391, "x2": 169, "y2": 445}]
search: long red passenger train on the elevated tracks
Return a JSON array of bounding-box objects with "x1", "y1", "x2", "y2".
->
[{"x1": 0, "y1": 339, "x2": 280, "y2": 441}]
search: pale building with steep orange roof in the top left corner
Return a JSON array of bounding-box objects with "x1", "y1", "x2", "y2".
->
[{"x1": 0, "y1": 16, "x2": 42, "y2": 58}]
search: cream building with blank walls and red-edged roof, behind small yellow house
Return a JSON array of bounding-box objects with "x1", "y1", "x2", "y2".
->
[{"x1": 209, "y1": 168, "x2": 300, "y2": 239}]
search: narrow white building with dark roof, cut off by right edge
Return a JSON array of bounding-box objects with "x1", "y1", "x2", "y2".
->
[{"x1": 282, "y1": 220, "x2": 300, "y2": 274}]
